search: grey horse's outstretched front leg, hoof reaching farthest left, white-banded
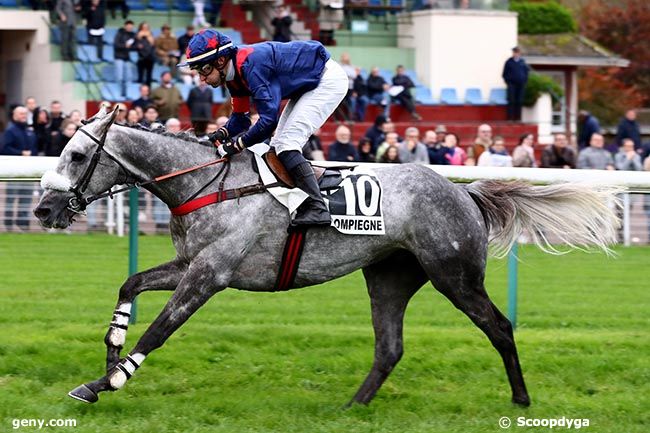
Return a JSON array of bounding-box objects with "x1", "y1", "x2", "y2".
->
[{"x1": 69, "y1": 250, "x2": 238, "y2": 403}]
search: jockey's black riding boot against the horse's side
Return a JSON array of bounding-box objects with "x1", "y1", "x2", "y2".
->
[{"x1": 289, "y1": 161, "x2": 332, "y2": 226}]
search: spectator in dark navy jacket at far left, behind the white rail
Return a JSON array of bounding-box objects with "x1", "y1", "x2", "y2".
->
[{"x1": 0, "y1": 105, "x2": 38, "y2": 231}]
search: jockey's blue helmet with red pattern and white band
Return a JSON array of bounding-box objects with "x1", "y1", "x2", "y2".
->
[{"x1": 178, "y1": 29, "x2": 237, "y2": 69}]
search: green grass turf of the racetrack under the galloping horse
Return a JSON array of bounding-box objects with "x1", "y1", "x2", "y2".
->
[{"x1": 0, "y1": 234, "x2": 650, "y2": 433}]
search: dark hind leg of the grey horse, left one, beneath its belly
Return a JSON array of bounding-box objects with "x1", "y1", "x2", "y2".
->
[{"x1": 350, "y1": 250, "x2": 428, "y2": 404}]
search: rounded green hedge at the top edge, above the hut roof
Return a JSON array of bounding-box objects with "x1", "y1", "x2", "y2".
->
[{"x1": 510, "y1": 1, "x2": 577, "y2": 35}]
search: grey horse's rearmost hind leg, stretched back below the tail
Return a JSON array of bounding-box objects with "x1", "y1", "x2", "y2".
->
[{"x1": 421, "y1": 256, "x2": 530, "y2": 406}]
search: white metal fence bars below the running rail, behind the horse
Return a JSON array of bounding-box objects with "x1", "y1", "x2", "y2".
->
[{"x1": 0, "y1": 182, "x2": 650, "y2": 245}]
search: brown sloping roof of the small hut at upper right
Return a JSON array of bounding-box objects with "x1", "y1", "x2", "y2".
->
[{"x1": 519, "y1": 33, "x2": 630, "y2": 68}]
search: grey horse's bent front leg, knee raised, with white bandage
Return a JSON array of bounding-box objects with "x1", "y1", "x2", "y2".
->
[{"x1": 104, "y1": 259, "x2": 188, "y2": 373}]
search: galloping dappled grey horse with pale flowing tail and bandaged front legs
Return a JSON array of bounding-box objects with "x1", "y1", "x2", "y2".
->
[{"x1": 34, "y1": 109, "x2": 617, "y2": 405}]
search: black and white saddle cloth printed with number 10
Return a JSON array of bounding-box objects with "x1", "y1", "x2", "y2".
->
[{"x1": 248, "y1": 143, "x2": 385, "y2": 235}]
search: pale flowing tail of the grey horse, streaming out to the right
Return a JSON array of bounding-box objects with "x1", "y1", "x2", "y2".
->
[{"x1": 465, "y1": 180, "x2": 620, "y2": 256}]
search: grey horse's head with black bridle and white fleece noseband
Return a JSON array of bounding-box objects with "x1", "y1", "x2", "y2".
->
[{"x1": 34, "y1": 106, "x2": 126, "y2": 228}]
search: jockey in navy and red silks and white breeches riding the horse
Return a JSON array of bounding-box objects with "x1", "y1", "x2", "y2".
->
[{"x1": 179, "y1": 29, "x2": 348, "y2": 225}]
